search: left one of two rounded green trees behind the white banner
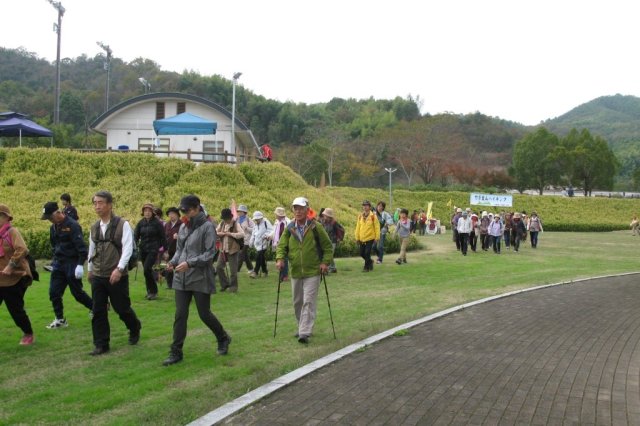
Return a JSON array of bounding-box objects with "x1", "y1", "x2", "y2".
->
[{"x1": 511, "y1": 127, "x2": 560, "y2": 195}]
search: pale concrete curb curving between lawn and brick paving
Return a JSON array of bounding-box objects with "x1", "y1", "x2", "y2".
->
[{"x1": 188, "y1": 272, "x2": 640, "y2": 426}]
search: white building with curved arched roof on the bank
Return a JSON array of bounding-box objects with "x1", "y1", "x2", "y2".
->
[{"x1": 91, "y1": 93, "x2": 258, "y2": 162}]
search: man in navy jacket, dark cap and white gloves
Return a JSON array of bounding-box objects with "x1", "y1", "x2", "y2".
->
[{"x1": 41, "y1": 201, "x2": 93, "y2": 329}]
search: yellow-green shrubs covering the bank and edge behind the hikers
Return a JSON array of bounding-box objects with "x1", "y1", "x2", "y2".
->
[{"x1": 0, "y1": 149, "x2": 640, "y2": 257}]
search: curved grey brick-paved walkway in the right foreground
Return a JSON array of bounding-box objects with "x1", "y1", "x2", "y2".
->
[{"x1": 223, "y1": 275, "x2": 640, "y2": 425}]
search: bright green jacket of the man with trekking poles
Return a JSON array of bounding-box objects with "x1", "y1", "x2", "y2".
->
[{"x1": 276, "y1": 219, "x2": 333, "y2": 278}]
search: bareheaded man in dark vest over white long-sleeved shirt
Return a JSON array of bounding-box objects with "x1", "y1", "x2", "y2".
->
[{"x1": 88, "y1": 191, "x2": 142, "y2": 356}]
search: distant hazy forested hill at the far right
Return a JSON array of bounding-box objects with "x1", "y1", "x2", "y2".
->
[{"x1": 543, "y1": 94, "x2": 640, "y2": 146}]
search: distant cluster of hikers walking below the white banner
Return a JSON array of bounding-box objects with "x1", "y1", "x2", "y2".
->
[{"x1": 450, "y1": 207, "x2": 543, "y2": 256}]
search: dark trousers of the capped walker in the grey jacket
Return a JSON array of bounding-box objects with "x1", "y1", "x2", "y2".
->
[{"x1": 171, "y1": 290, "x2": 227, "y2": 353}]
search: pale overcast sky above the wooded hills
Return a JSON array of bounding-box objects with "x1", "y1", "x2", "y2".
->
[{"x1": 0, "y1": 0, "x2": 640, "y2": 125}]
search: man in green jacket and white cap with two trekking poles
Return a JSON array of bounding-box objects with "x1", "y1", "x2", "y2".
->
[{"x1": 276, "y1": 197, "x2": 333, "y2": 344}]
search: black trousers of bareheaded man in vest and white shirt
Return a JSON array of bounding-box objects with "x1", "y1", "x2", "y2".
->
[{"x1": 91, "y1": 275, "x2": 141, "y2": 347}]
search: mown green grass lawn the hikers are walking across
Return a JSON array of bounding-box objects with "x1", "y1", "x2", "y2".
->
[{"x1": 0, "y1": 232, "x2": 640, "y2": 425}]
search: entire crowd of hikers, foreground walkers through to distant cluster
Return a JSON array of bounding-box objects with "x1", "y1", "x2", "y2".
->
[{"x1": 0, "y1": 191, "x2": 542, "y2": 365}]
